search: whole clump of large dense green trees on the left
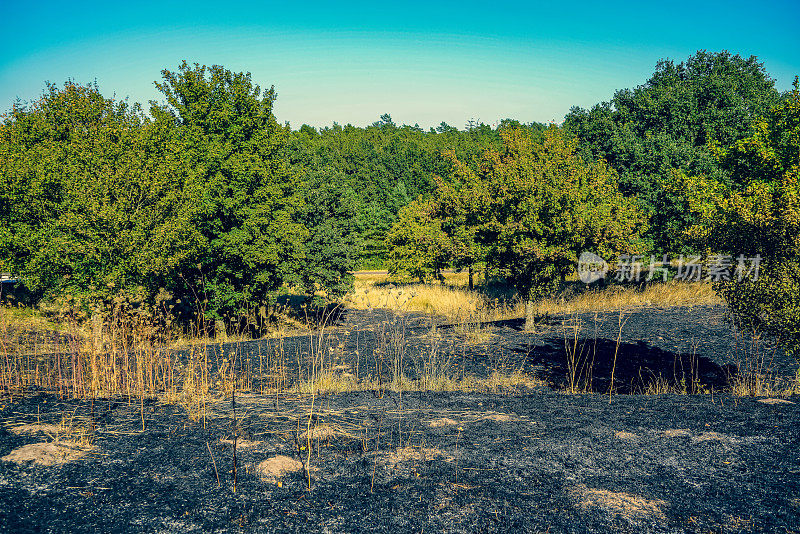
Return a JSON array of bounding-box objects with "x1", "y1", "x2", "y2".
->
[{"x1": 0, "y1": 63, "x2": 350, "y2": 318}]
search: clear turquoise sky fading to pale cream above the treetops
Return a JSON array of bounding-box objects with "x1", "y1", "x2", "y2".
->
[{"x1": 0, "y1": 0, "x2": 800, "y2": 128}]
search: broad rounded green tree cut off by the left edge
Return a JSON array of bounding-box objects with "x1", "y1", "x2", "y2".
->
[{"x1": 0, "y1": 82, "x2": 172, "y2": 311}]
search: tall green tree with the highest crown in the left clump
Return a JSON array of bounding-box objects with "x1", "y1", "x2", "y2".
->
[{"x1": 151, "y1": 61, "x2": 307, "y2": 318}]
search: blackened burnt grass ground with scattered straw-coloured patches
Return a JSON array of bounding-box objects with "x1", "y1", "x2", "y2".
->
[{"x1": 0, "y1": 307, "x2": 800, "y2": 532}]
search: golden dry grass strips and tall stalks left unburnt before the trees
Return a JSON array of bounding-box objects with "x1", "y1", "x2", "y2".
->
[{"x1": 0, "y1": 273, "x2": 800, "y2": 406}]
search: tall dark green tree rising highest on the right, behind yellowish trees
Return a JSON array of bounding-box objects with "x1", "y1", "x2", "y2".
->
[{"x1": 564, "y1": 50, "x2": 780, "y2": 253}]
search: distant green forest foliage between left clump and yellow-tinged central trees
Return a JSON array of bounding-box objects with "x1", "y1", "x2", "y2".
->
[{"x1": 289, "y1": 118, "x2": 543, "y2": 269}]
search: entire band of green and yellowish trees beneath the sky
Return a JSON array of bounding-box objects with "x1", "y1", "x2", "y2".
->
[{"x1": 0, "y1": 51, "x2": 800, "y2": 352}]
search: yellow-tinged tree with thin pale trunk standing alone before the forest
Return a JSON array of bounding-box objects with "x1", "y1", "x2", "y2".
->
[{"x1": 456, "y1": 126, "x2": 644, "y2": 328}]
